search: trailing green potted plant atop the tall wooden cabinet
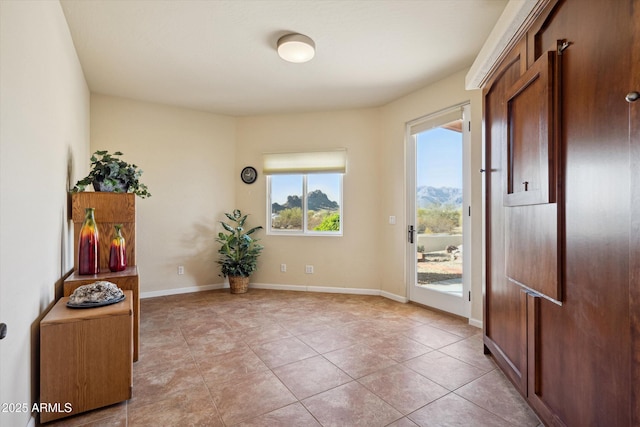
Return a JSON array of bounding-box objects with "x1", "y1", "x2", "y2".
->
[{"x1": 71, "y1": 150, "x2": 151, "y2": 199}]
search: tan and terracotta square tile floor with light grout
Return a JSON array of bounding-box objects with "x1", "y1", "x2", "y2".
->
[{"x1": 46, "y1": 289, "x2": 540, "y2": 427}]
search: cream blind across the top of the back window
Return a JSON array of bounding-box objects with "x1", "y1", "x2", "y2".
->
[{"x1": 262, "y1": 148, "x2": 347, "y2": 175}]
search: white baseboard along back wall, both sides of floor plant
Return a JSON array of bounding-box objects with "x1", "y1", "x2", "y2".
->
[{"x1": 140, "y1": 281, "x2": 408, "y2": 303}]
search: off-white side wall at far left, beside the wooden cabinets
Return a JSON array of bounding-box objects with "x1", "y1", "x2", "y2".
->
[{"x1": 0, "y1": 1, "x2": 89, "y2": 426}]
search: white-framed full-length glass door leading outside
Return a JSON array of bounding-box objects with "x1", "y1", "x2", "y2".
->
[{"x1": 407, "y1": 104, "x2": 471, "y2": 318}]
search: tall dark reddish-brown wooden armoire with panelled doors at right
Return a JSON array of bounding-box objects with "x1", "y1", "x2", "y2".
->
[{"x1": 483, "y1": 0, "x2": 640, "y2": 427}]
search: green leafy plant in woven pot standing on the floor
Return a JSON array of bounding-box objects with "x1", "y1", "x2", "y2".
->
[{"x1": 216, "y1": 209, "x2": 263, "y2": 294}]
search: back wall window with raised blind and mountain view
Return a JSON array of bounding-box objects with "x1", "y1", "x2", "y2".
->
[{"x1": 263, "y1": 150, "x2": 346, "y2": 236}]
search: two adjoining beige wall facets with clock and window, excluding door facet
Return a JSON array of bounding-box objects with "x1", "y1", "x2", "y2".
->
[{"x1": 91, "y1": 100, "x2": 390, "y2": 296}]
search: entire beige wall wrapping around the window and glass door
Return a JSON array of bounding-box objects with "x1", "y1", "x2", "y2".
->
[{"x1": 91, "y1": 70, "x2": 482, "y2": 321}]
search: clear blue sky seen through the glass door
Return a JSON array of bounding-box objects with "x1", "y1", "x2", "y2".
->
[{"x1": 416, "y1": 128, "x2": 462, "y2": 188}]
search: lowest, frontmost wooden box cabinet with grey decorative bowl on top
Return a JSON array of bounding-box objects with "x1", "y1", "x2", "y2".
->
[{"x1": 40, "y1": 291, "x2": 133, "y2": 422}]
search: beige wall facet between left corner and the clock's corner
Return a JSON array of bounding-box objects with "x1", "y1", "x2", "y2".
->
[{"x1": 91, "y1": 94, "x2": 237, "y2": 296}]
